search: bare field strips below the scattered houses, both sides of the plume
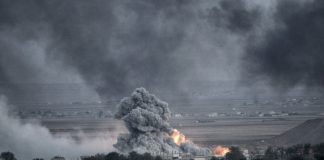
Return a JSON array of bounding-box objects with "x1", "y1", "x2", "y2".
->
[{"x1": 42, "y1": 116, "x2": 324, "y2": 146}]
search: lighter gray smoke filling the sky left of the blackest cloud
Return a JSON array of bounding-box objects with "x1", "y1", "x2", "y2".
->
[{"x1": 0, "y1": 0, "x2": 262, "y2": 99}]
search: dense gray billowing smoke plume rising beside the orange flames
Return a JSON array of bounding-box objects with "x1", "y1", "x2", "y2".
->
[{"x1": 114, "y1": 88, "x2": 210, "y2": 154}]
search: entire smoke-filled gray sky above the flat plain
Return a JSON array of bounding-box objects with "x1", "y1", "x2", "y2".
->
[{"x1": 0, "y1": 0, "x2": 324, "y2": 99}]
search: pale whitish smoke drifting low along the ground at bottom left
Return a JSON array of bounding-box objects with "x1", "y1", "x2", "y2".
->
[{"x1": 0, "y1": 97, "x2": 116, "y2": 159}]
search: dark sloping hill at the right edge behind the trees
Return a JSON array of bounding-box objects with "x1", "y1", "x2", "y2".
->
[{"x1": 270, "y1": 118, "x2": 324, "y2": 146}]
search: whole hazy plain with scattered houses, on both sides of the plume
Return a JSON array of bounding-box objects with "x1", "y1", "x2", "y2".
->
[{"x1": 12, "y1": 86, "x2": 324, "y2": 148}]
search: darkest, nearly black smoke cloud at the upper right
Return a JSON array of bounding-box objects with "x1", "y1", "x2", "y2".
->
[{"x1": 244, "y1": 0, "x2": 324, "y2": 88}]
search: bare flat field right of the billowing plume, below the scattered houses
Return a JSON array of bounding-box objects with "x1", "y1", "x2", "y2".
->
[{"x1": 173, "y1": 116, "x2": 322, "y2": 145}]
